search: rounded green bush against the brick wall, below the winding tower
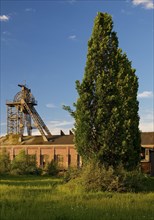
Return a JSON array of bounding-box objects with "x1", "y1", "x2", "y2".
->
[{"x1": 11, "y1": 149, "x2": 37, "y2": 175}]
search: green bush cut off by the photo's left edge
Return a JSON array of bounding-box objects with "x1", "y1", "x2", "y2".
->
[{"x1": 0, "y1": 148, "x2": 11, "y2": 174}]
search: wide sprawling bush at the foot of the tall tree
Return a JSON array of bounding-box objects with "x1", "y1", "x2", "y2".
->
[{"x1": 65, "y1": 162, "x2": 147, "y2": 192}]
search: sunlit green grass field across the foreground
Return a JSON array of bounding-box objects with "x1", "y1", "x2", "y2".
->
[{"x1": 0, "y1": 176, "x2": 154, "y2": 220}]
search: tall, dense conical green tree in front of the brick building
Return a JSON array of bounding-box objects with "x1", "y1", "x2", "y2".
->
[{"x1": 64, "y1": 13, "x2": 140, "y2": 169}]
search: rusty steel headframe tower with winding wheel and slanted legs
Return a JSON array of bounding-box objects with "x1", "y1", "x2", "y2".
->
[{"x1": 6, "y1": 84, "x2": 52, "y2": 141}]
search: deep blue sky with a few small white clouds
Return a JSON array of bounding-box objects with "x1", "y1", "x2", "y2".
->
[{"x1": 0, "y1": 0, "x2": 154, "y2": 135}]
